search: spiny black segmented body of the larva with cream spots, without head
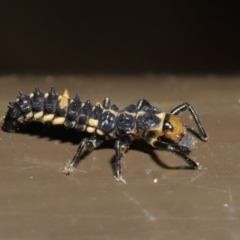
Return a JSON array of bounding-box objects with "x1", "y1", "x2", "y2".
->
[{"x1": 3, "y1": 87, "x2": 162, "y2": 138}]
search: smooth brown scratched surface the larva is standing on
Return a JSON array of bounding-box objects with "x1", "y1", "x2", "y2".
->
[{"x1": 0, "y1": 75, "x2": 240, "y2": 239}]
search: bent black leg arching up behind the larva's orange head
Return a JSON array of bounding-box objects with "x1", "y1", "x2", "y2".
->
[{"x1": 170, "y1": 103, "x2": 208, "y2": 141}]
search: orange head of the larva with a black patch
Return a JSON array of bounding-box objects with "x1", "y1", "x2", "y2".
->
[{"x1": 163, "y1": 114, "x2": 186, "y2": 142}]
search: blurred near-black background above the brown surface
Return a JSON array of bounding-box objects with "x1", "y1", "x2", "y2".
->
[{"x1": 0, "y1": 0, "x2": 240, "y2": 74}]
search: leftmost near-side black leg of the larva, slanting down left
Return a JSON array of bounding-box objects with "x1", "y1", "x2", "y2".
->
[{"x1": 63, "y1": 136, "x2": 103, "y2": 175}]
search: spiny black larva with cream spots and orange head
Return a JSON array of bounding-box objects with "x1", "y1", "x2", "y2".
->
[{"x1": 2, "y1": 86, "x2": 208, "y2": 183}]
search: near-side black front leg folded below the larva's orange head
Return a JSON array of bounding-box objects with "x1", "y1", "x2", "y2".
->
[{"x1": 153, "y1": 141, "x2": 198, "y2": 170}]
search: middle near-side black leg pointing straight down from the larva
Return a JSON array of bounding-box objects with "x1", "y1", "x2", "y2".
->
[{"x1": 113, "y1": 139, "x2": 130, "y2": 184}]
